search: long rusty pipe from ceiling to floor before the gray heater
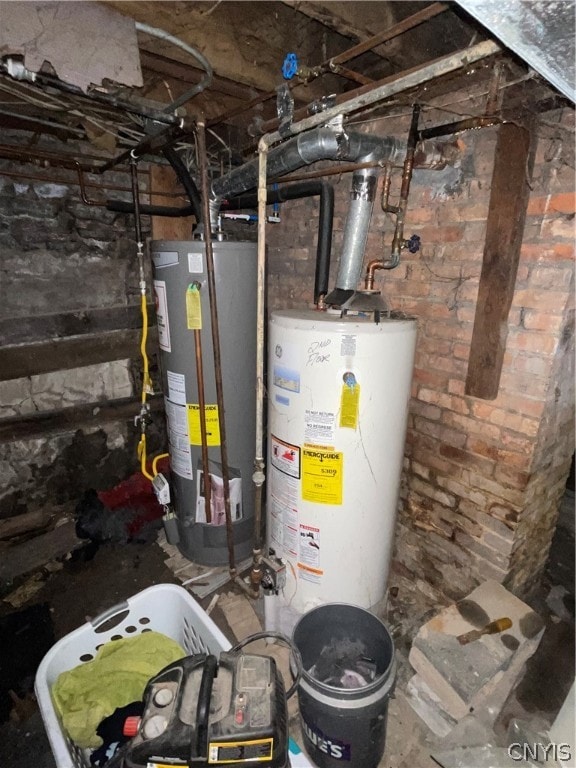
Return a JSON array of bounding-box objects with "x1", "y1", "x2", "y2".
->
[{"x1": 196, "y1": 119, "x2": 236, "y2": 578}]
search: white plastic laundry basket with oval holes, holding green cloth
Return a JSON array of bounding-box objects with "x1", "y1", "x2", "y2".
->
[{"x1": 34, "y1": 584, "x2": 231, "y2": 768}]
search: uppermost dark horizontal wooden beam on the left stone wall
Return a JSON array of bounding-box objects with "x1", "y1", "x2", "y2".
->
[{"x1": 0, "y1": 304, "x2": 156, "y2": 345}]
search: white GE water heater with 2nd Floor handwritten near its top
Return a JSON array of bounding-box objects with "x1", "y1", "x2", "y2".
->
[{"x1": 266, "y1": 310, "x2": 416, "y2": 631}]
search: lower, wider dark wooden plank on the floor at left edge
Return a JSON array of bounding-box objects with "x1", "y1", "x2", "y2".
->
[{"x1": 0, "y1": 520, "x2": 84, "y2": 582}]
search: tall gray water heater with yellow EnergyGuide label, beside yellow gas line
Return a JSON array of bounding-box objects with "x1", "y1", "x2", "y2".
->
[{"x1": 151, "y1": 240, "x2": 257, "y2": 565}]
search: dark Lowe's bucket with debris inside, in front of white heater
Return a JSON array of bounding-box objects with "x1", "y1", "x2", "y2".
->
[{"x1": 293, "y1": 603, "x2": 396, "y2": 768}]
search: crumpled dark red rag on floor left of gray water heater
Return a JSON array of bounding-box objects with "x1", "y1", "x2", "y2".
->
[{"x1": 98, "y1": 457, "x2": 170, "y2": 538}]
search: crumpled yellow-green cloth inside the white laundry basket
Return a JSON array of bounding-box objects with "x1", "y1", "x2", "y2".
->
[{"x1": 52, "y1": 632, "x2": 186, "y2": 748}]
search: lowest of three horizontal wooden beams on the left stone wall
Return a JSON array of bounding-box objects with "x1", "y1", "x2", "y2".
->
[{"x1": 0, "y1": 395, "x2": 164, "y2": 443}]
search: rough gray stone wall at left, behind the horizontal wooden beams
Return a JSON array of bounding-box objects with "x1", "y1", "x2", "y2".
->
[{"x1": 0, "y1": 132, "x2": 164, "y2": 517}]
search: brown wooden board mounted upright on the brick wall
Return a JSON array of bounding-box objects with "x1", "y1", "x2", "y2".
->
[{"x1": 466, "y1": 123, "x2": 535, "y2": 400}]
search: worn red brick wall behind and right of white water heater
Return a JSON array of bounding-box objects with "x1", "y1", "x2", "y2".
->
[{"x1": 268, "y1": 100, "x2": 575, "y2": 598}]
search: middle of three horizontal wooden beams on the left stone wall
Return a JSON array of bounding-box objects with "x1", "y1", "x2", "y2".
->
[{"x1": 0, "y1": 328, "x2": 158, "y2": 381}]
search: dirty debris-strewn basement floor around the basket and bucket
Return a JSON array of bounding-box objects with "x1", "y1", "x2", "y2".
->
[{"x1": 0, "y1": 488, "x2": 574, "y2": 768}]
